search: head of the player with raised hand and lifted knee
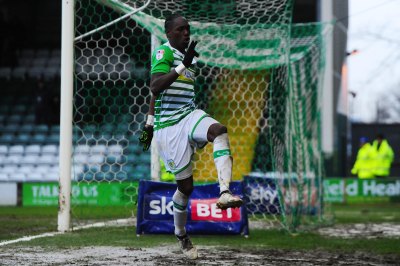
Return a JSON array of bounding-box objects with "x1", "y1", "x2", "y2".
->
[{"x1": 164, "y1": 13, "x2": 190, "y2": 52}]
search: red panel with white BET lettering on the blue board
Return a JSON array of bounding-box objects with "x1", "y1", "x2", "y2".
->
[{"x1": 190, "y1": 198, "x2": 241, "y2": 222}]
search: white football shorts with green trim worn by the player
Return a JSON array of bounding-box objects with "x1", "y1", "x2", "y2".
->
[{"x1": 154, "y1": 109, "x2": 219, "y2": 180}]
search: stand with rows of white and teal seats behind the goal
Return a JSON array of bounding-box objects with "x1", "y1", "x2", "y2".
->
[{"x1": 0, "y1": 49, "x2": 150, "y2": 182}]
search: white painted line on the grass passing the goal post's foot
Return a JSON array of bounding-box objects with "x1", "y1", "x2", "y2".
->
[{"x1": 0, "y1": 218, "x2": 136, "y2": 246}]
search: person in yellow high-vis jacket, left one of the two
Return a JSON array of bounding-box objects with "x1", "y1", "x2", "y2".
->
[{"x1": 351, "y1": 137, "x2": 374, "y2": 179}]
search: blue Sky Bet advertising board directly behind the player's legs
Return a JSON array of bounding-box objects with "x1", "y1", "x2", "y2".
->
[{"x1": 136, "y1": 180, "x2": 248, "y2": 235}]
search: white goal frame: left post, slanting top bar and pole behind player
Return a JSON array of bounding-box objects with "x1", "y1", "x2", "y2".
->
[{"x1": 57, "y1": 0, "x2": 155, "y2": 232}]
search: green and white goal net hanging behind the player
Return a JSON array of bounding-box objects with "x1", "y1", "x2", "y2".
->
[{"x1": 72, "y1": 0, "x2": 327, "y2": 231}]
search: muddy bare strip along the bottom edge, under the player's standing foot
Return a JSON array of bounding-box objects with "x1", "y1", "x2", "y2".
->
[{"x1": 0, "y1": 246, "x2": 400, "y2": 266}]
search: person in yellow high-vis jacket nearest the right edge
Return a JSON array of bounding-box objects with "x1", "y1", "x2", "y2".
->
[{"x1": 372, "y1": 134, "x2": 394, "y2": 177}]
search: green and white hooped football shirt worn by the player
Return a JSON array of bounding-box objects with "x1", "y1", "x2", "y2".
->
[{"x1": 151, "y1": 42, "x2": 196, "y2": 130}]
